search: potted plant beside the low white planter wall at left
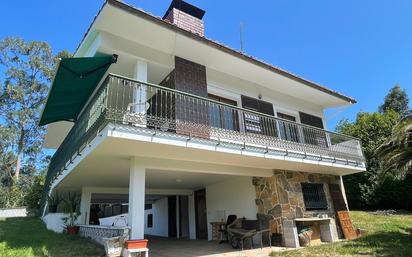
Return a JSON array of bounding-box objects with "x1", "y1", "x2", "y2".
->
[{"x1": 62, "y1": 192, "x2": 80, "y2": 235}]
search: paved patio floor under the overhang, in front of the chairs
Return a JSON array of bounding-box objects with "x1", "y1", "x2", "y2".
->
[{"x1": 148, "y1": 237, "x2": 286, "y2": 257}]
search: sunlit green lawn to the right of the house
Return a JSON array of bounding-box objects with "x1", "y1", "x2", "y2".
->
[{"x1": 271, "y1": 211, "x2": 412, "y2": 257}]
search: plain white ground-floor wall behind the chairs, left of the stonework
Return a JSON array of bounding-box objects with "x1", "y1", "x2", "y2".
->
[{"x1": 206, "y1": 177, "x2": 257, "y2": 240}]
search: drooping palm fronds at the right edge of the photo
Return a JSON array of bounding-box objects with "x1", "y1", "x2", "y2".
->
[{"x1": 376, "y1": 115, "x2": 412, "y2": 176}]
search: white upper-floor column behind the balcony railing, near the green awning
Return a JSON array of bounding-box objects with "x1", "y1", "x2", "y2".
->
[{"x1": 133, "y1": 60, "x2": 147, "y2": 125}]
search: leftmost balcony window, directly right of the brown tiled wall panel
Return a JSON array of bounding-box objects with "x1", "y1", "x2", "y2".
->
[{"x1": 208, "y1": 94, "x2": 239, "y2": 130}]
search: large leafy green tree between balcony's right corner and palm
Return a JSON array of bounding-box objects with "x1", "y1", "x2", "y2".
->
[{"x1": 336, "y1": 110, "x2": 399, "y2": 209}]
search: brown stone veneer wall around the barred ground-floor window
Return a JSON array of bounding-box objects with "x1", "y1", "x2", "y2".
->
[{"x1": 253, "y1": 171, "x2": 340, "y2": 233}]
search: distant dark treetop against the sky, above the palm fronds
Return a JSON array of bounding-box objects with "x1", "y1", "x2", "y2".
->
[{"x1": 379, "y1": 85, "x2": 410, "y2": 117}]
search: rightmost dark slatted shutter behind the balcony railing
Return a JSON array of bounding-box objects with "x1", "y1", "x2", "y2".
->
[{"x1": 299, "y1": 112, "x2": 328, "y2": 147}]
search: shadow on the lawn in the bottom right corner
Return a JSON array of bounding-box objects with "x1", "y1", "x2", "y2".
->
[{"x1": 343, "y1": 228, "x2": 412, "y2": 257}]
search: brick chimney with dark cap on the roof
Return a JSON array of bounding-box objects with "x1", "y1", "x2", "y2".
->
[{"x1": 163, "y1": 0, "x2": 205, "y2": 37}]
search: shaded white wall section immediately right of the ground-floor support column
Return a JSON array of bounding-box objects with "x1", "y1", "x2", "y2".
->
[{"x1": 144, "y1": 197, "x2": 169, "y2": 237}]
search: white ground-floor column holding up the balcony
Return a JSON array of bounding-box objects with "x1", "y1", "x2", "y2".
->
[{"x1": 129, "y1": 158, "x2": 146, "y2": 239}]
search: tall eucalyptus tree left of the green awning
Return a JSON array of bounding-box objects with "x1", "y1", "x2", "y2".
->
[{"x1": 0, "y1": 38, "x2": 71, "y2": 209}]
